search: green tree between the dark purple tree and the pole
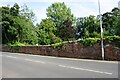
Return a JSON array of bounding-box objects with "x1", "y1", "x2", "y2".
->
[{"x1": 76, "y1": 15, "x2": 100, "y2": 39}]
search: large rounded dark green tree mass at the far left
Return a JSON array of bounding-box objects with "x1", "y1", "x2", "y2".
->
[{"x1": 0, "y1": 3, "x2": 37, "y2": 44}]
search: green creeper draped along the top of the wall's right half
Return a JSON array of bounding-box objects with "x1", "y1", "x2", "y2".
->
[{"x1": 52, "y1": 36, "x2": 120, "y2": 48}]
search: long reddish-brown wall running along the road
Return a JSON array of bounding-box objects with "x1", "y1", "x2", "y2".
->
[{"x1": 2, "y1": 43, "x2": 120, "y2": 61}]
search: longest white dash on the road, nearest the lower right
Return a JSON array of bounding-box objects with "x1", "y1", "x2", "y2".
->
[{"x1": 58, "y1": 65, "x2": 113, "y2": 75}]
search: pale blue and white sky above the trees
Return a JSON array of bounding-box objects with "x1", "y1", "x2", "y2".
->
[{"x1": 0, "y1": 0, "x2": 120, "y2": 23}]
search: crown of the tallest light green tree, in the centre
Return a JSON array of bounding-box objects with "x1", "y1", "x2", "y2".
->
[{"x1": 47, "y1": 2, "x2": 74, "y2": 22}]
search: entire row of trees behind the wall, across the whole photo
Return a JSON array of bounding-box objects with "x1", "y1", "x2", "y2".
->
[{"x1": 0, "y1": 2, "x2": 120, "y2": 45}]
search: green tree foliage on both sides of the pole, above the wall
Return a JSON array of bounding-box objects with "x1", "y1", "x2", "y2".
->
[{"x1": 76, "y1": 8, "x2": 120, "y2": 39}]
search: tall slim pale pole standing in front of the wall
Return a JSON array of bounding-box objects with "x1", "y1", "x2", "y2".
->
[{"x1": 98, "y1": 0, "x2": 104, "y2": 60}]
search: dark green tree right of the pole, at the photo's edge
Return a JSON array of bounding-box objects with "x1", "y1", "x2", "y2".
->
[{"x1": 103, "y1": 8, "x2": 120, "y2": 36}]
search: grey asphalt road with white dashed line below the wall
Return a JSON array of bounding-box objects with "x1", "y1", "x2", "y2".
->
[{"x1": 2, "y1": 52, "x2": 118, "y2": 78}]
